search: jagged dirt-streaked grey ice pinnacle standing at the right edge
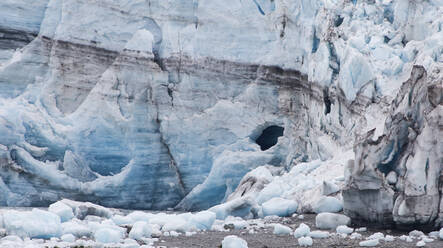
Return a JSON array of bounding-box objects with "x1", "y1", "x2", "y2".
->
[{"x1": 343, "y1": 66, "x2": 443, "y2": 228}]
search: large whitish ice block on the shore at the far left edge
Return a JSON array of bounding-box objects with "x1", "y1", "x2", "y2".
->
[{"x1": 3, "y1": 208, "x2": 62, "y2": 239}]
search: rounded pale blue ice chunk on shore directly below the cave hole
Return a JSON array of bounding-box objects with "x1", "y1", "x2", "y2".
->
[{"x1": 262, "y1": 197, "x2": 298, "y2": 217}]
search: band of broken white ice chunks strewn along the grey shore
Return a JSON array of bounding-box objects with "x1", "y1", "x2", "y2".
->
[{"x1": 0, "y1": 199, "x2": 443, "y2": 248}]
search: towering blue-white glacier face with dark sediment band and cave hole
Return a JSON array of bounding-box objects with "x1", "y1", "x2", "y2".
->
[{"x1": 0, "y1": 0, "x2": 443, "y2": 228}]
